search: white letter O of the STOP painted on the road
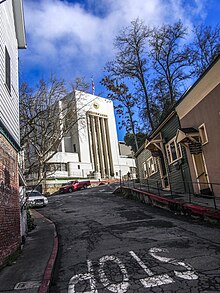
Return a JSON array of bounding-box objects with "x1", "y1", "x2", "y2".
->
[{"x1": 99, "y1": 255, "x2": 129, "y2": 293}]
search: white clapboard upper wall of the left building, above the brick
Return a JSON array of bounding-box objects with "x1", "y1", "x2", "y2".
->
[{"x1": 0, "y1": 0, "x2": 20, "y2": 143}]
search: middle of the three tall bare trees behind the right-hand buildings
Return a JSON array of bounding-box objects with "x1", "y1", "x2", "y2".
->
[{"x1": 150, "y1": 21, "x2": 190, "y2": 106}]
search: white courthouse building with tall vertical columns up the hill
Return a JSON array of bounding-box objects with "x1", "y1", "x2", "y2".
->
[{"x1": 48, "y1": 91, "x2": 136, "y2": 179}]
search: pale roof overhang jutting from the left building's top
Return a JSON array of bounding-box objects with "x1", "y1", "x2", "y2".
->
[{"x1": 12, "y1": 0, "x2": 27, "y2": 49}]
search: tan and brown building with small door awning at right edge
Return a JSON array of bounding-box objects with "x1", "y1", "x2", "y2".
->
[{"x1": 176, "y1": 55, "x2": 220, "y2": 196}]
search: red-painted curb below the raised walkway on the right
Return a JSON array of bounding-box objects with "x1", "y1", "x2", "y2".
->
[{"x1": 114, "y1": 186, "x2": 220, "y2": 222}]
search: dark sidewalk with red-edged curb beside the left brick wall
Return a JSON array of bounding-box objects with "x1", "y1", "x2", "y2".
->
[{"x1": 0, "y1": 210, "x2": 58, "y2": 293}]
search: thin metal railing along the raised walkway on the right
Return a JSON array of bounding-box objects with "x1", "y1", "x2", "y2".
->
[{"x1": 120, "y1": 178, "x2": 220, "y2": 210}]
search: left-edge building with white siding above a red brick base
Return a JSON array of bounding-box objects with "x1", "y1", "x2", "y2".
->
[{"x1": 0, "y1": 0, "x2": 26, "y2": 267}]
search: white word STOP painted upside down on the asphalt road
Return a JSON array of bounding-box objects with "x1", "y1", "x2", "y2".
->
[{"x1": 68, "y1": 247, "x2": 198, "y2": 293}]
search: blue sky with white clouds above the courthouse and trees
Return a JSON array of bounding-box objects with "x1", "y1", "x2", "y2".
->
[{"x1": 19, "y1": 0, "x2": 220, "y2": 140}]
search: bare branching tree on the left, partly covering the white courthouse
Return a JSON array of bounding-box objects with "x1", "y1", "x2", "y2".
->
[{"x1": 20, "y1": 77, "x2": 88, "y2": 182}]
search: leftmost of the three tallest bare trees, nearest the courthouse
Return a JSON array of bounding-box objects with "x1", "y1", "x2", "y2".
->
[{"x1": 103, "y1": 19, "x2": 154, "y2": 129}]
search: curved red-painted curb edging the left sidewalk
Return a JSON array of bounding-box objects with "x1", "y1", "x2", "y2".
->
[{"x1": 33, "y1": 210, "x2": 58, "y2": 293}]
